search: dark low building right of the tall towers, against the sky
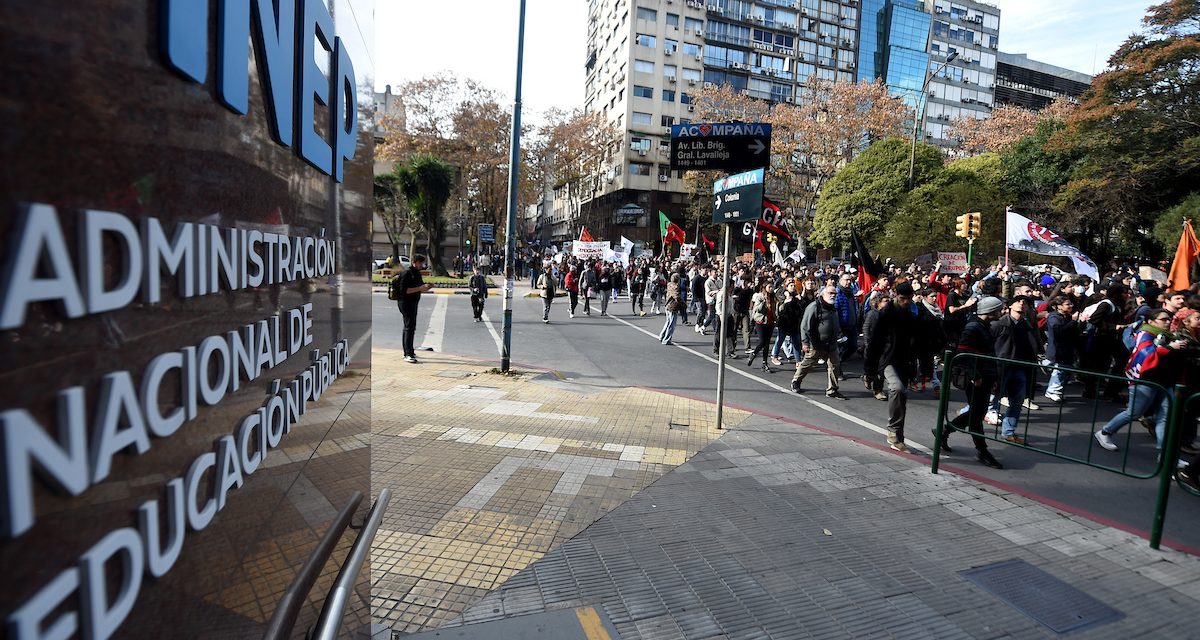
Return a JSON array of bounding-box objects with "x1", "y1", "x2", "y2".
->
[{"x1": 996, "y1": 52, "x2": 1092, "y2": 110}]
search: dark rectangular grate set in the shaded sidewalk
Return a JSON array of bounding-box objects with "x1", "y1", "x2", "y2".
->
[{"x1": 959, "y1": 560, "x2": 1124, "y2": 633}]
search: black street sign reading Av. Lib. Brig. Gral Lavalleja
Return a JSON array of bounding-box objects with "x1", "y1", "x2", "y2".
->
[{"x1": 671, "y1": 122, "x2": 770, "y2": 173}]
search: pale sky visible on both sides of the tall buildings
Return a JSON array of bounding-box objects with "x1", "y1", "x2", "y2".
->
[{"x1": 374, "y1": 0, "x2": 1150, "y2": 116}]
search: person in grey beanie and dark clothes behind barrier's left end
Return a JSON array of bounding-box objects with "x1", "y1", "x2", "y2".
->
[{"x1": 938, "y1": 295, "x2": 1004, "y2": 468}]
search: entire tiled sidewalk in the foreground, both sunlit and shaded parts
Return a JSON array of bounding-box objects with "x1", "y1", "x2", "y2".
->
[{"x1": 372, "y1": 353, "x2": 1200, "y2": 640}]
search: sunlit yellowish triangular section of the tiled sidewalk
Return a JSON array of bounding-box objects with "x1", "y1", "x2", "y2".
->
[{"x1": 371, "y1": 348, "x2": 748, "y2": 632}]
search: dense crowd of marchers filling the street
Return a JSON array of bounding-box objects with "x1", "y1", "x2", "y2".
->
[{"x1": 528, "y1": 250, "x2": 1200, "y2": 490}]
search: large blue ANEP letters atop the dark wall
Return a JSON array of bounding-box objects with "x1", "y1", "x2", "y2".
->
[{"x1": 160, "y1": 0, "x2": 359, "y2": 181}]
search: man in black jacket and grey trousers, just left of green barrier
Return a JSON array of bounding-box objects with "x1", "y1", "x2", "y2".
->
[{"x1": 863, "y1": 282, "x2": 936, "y2": 453}]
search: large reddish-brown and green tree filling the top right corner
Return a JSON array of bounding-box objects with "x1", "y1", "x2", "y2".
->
[{"x1": 1050, "y1": 0, "x2": 1200, "y2": 258}]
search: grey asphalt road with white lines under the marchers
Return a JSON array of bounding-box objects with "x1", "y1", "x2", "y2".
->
[{"x1": 372, "y1": 285, "x2": 1200, "y2": 552}]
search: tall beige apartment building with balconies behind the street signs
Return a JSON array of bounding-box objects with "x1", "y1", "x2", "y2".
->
[{"x1": 576, "y1": 0, "x2": 859, "y2": 243}]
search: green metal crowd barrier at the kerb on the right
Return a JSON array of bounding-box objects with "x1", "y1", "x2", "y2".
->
[{"x1": 931, "y1": 351, "x2": 1200, "y2": 549}]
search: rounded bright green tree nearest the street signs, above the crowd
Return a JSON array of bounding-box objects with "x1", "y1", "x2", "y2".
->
[{"x1": 811, "y1": 138, "x2": 942, "y2": 247}]
